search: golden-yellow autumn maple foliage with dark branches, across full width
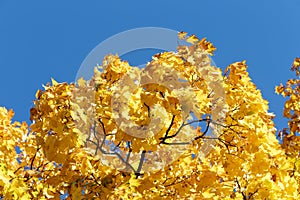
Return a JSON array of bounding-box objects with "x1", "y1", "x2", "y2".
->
[{"x1": 0, "y1": 32, "x2": 300, "y2": 199}]
